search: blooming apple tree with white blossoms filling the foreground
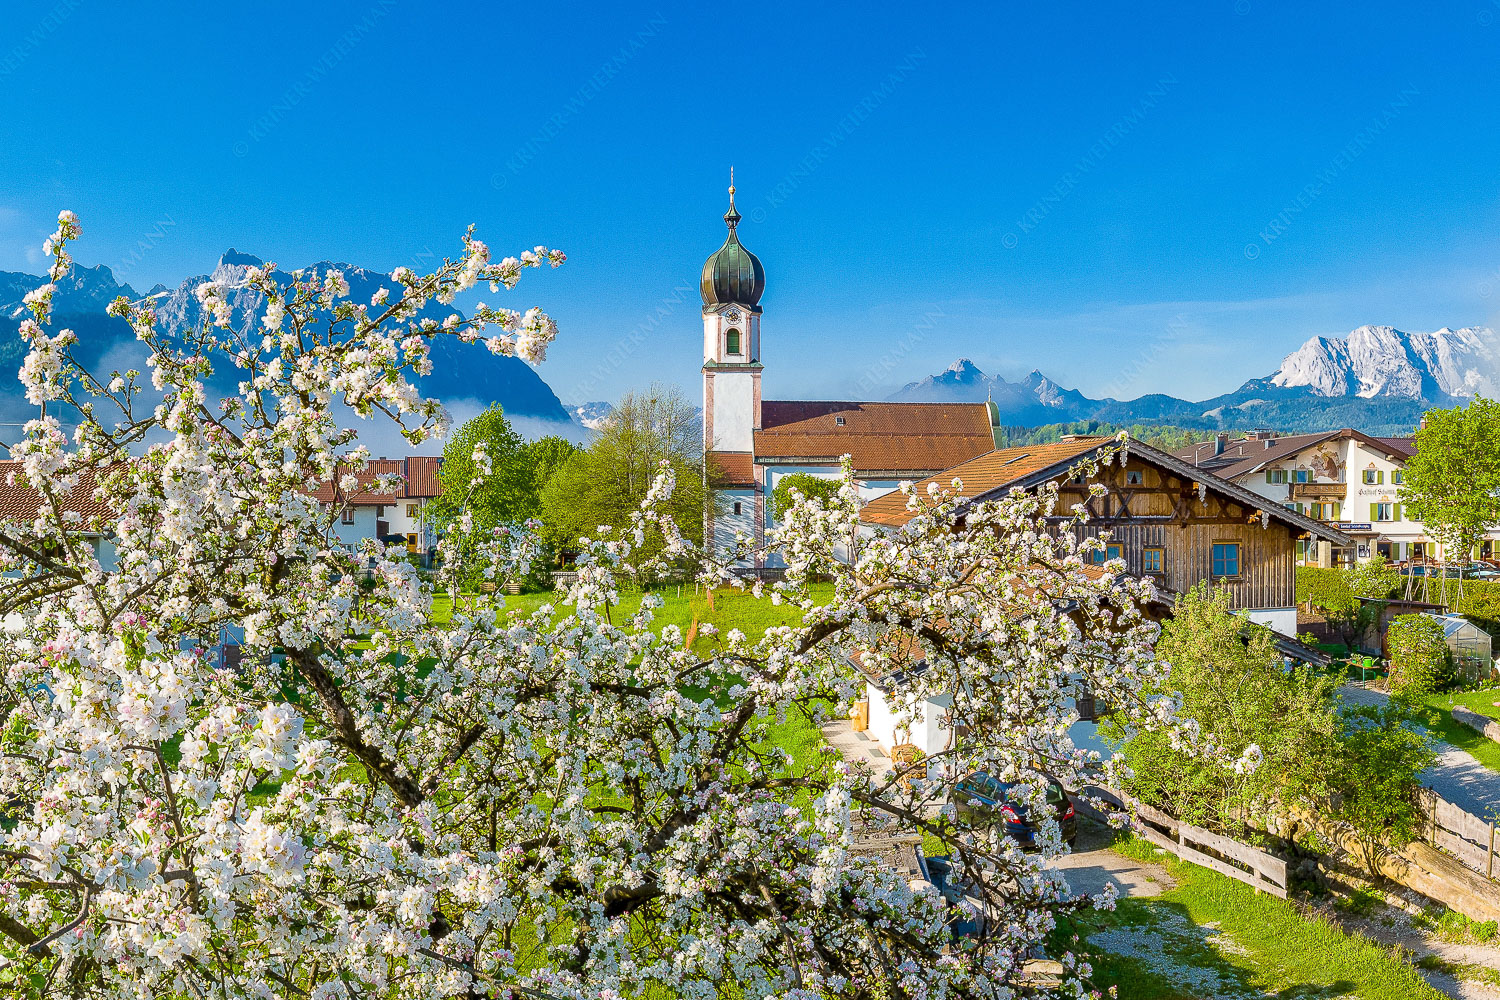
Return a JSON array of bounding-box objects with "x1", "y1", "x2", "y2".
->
[{"x1": 0, "y1": 213, "x2": 1172, "y2": 1000}]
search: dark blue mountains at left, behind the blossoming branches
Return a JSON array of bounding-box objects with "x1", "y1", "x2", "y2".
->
[{"x1": 0, "y1": 249, "x2": 572, "y2": 423}]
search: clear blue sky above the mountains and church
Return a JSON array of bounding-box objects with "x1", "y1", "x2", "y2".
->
[{"x1": 0, "y1": 0, "x2": 1500, "y2": 402}]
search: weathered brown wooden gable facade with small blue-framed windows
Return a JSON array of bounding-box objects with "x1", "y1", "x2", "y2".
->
[{"x1": 1058, "y1": 448, "x2": 1308, "y2": 609}]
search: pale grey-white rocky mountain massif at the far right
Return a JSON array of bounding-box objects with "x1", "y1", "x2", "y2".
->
[{"x1": 1271, "y1": 327, "x2": 1500, "y2": 400}]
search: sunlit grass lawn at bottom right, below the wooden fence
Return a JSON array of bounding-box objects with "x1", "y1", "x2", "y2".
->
[{"x1": 1062, "y1": 838, "x2": 1443, "y2": 1000}]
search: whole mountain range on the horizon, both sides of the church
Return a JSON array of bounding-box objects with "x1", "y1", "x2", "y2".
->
[{"x1": 0, "y1": 256, "x2": 1482, "y2": 433}]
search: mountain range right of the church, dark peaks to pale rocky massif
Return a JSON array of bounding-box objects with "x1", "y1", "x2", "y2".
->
[{"x1": 891, "y1": 327, "x2": 1500, "y2": 433}]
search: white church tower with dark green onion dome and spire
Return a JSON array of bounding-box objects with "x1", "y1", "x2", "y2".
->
[{"x1": 701, "y1": 179, "x2": 765, "y2": 563}]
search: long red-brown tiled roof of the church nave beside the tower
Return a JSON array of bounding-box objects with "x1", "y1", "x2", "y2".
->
[{"x1": 755, "y1": 400, "x2": 995, "y2": 475}]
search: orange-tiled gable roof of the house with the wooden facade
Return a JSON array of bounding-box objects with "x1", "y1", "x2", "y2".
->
[{"x1": 860, "y1": 438, "x2": 1353, "y2": 546}]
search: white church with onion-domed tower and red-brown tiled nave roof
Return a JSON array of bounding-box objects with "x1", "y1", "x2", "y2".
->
[{"x1": 701, "y1": 183, "x2": 999, "y2": 571}]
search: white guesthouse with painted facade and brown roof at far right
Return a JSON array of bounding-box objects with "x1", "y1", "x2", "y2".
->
[{"x1": 1178, "y1": 427, "x2": 1500, "y2": 565}]
